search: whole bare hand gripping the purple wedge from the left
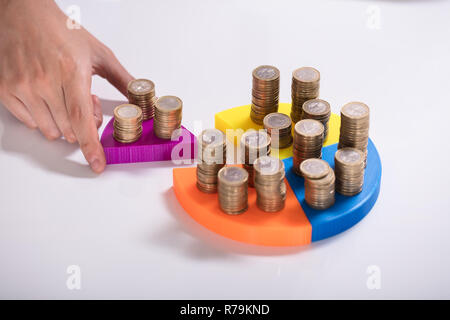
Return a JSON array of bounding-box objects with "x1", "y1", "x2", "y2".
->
[{"x1": 0, "y1": 0, "x2": 133, "y2": 173}]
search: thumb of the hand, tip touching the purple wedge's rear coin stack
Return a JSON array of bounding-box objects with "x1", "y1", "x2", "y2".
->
[{"x1": 94, "y1": 45, "x2": 133, "y2": 97}]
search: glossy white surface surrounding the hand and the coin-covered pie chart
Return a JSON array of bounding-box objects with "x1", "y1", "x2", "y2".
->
[{"x1": 0, "y1": 0, "x2": 450, "y2": 299}]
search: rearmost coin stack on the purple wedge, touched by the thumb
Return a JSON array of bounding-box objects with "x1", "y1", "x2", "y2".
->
[{"x1": 128, "y1": 79, "x2": 156, "y2": 121}]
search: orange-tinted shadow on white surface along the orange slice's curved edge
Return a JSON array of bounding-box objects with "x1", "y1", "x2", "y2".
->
[{"x1": 156, "y1": 188, "x2": 339, "y2": 259}]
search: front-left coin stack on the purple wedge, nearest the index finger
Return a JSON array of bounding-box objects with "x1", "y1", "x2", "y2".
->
[{"x1": 113, "y1": 104, "x2": 142, "y2": 143}]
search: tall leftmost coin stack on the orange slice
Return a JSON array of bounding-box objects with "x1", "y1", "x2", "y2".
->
[{"x1": 197, "y1": 129, "x2": 227, "y2": 193}]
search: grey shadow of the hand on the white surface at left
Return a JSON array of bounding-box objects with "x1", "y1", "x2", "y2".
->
[{"x1": 0, "y1": 105, "x2": 97, "y2": 178}]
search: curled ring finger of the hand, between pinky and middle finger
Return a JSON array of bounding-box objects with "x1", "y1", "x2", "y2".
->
[{"x1": 16, "y1": 89, "x2": 61, "y2": 140}]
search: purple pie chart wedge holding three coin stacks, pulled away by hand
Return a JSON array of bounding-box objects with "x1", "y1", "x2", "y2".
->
[{"x1": 100, "y1": 118, "x2": 197, "y2": 164}]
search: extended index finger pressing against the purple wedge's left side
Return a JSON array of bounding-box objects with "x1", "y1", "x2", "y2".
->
[{"x1": 63, "y1": 74, "x2": 106, "y2": 173}]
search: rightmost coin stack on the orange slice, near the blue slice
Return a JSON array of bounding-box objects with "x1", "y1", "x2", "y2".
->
[{"x1": 253, "y1": 156, "x2": 286, "y2": 212}]
